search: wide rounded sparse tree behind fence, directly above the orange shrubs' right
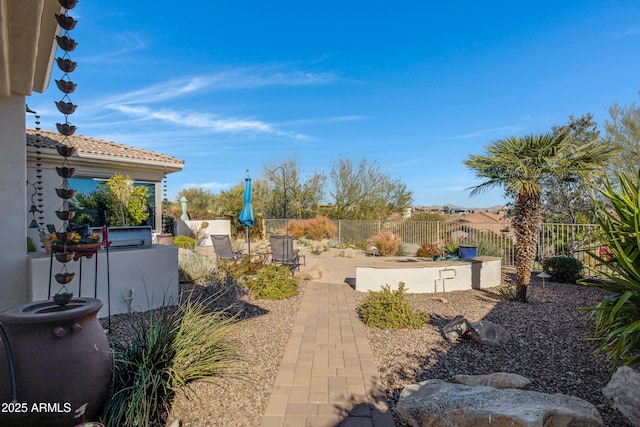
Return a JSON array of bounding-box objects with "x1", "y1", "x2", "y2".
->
[{"x1": 329, "y1": 158, "x2": 413, "y2": 220}]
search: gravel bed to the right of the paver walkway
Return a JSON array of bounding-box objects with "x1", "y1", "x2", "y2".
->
[{"x1": 358, "y1": 277, "x2": 630, "y2": 427}]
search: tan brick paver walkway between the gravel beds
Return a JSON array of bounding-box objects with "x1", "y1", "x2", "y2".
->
[{"x1": 262, "y1": 281, "x2": 394, "y2": 427}]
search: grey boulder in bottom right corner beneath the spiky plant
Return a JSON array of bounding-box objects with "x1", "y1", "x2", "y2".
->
[{"x1": 602, "y1": 366, "x2": 640, "y2": 427}]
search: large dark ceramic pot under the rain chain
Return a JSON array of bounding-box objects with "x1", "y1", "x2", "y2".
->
[{"x1": 0, "y1": 298, "x2": 112, "y2": 426}]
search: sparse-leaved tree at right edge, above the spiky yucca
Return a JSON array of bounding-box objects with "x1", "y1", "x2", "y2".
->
[{"x1": 604, "y1": 92, "x2": 640, "y2": 181}]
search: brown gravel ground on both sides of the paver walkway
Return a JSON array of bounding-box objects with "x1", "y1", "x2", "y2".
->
[{"x1": 105, "y1": 272, "x2": 629, "y2": 427}]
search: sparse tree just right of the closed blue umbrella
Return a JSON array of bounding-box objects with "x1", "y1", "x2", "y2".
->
[{"x1": 264, "y1": 159, "x2": 326, "y2": 219}]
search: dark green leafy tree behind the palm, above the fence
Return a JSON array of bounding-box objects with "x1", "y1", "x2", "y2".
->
[{"x1": 541, "y1": 114, "x2": 606, "y2": 224}]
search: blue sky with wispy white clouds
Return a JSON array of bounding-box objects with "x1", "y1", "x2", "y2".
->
[{"x1": 27, "y1": 0, "x2": 640, "y2": 207}]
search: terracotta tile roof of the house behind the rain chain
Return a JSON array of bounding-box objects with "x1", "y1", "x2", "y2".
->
[{"x1": 27, "y1": 129, "x2": 184, "y2": 167}]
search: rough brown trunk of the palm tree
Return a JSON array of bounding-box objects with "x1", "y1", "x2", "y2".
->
[{"x1": 512, "y1": 192, "x2": 542, "y2": 302}]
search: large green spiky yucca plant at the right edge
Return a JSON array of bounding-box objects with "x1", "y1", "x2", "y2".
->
[{"x1": 579, "y1": 171, "x2": 640, "y2": 372}]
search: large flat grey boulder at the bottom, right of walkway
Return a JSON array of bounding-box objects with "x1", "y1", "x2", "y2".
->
[{"x1": 396, "y1": 380, "x2": 602, "y2": 427}]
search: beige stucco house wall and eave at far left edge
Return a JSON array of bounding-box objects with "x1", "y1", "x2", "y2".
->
[{"x1": 0, "y1": 0, "x2": 62, "y2": 311}]
